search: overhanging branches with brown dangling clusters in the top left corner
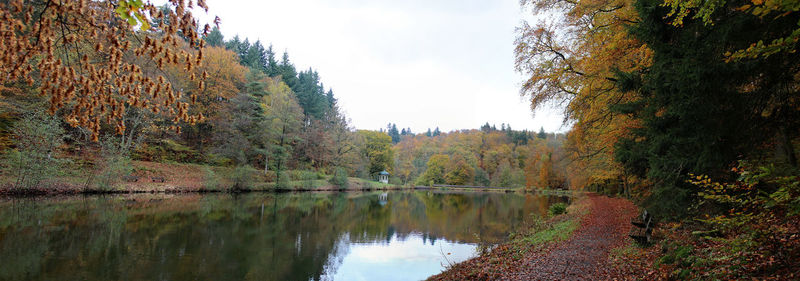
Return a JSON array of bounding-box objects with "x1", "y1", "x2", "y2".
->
[{"x1": 0, "y1": 0, "x2": 219, "y2": 140}]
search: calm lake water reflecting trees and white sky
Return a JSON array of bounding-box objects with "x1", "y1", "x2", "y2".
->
[{"x1": 0, "y1": 191, "x2": 566, "y2": 281}]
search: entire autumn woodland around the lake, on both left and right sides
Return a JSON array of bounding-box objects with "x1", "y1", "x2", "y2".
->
[{"x1": 0, "y1": 0, "x2": 800, "y2": 280}]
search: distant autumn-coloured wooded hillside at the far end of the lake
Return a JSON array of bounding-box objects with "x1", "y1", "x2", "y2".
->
[{"x1": 388, "y1": 123, "x2": 569, "y2": 189}]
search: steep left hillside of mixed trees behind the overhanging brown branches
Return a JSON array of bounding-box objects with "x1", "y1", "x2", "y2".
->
[{"x1": 0, "y1": 19, "x2": 367, "y2": 187}]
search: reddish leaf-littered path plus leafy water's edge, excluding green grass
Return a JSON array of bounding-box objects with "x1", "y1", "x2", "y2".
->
[{"x1": 431, "y1": 194, "x2": 637, "y2": 280}]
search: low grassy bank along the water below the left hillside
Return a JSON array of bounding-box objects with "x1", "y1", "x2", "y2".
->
[{"x1": 0, "y1": 161, "x2": 411, "y2": 195}]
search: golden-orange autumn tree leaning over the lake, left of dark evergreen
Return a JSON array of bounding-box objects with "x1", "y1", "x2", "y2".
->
[{"x1": 515, "y1": 0, "x2": 651, "y2": 190}]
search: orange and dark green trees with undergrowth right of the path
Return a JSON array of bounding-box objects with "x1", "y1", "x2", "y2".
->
[{"x1": 516, "y1": 0, "x2": 800, "y2": 280}]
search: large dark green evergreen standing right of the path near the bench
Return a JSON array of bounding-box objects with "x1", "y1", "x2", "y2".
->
[{"x1": 614, "y1": 0, "x2": 799, "y2": 215}]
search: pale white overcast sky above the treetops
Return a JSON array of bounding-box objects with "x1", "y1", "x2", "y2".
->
[{"x1": 198, "y1": 0, "x2": 567, "y2": 132}]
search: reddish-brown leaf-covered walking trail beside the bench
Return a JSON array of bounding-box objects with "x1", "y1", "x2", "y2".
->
[{"x1": 501, "y1": 195, "x2": 637, "y2": 280}]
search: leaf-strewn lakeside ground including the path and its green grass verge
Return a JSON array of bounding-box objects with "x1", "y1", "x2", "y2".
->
[{"x1": 430, "y1": 194, "x2": 645, "y2": 280}]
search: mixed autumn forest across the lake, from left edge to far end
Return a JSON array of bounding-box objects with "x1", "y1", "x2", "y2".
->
[{"x1": 0, "y1": 0, "x2": 567, "y2": 193}]
